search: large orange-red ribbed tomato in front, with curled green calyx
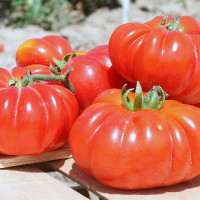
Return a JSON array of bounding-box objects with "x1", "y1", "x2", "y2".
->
[{"x1": 69, "y1": 83, "x2": 200, "y2": 189}]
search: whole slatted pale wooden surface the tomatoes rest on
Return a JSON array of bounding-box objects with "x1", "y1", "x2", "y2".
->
[{"x1": 0, "y1": 145, "x2": 200, "y2": 200}]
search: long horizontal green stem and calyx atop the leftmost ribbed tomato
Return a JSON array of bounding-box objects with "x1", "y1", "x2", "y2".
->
[{"x1": 9, "y1": 67, "x2": 75, "y2": 94}]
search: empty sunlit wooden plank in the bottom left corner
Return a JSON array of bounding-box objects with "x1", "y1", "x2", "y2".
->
[{"x1": 0, "y1": 163, "x2": 87, "y2": 200}]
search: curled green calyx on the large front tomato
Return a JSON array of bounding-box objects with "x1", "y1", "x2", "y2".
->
[{"x1": 121, "y1": 82, "x2": 167, "y2": 112}]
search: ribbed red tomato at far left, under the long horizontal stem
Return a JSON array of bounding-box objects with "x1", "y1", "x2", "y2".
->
[{"x1": 0, "y1": 68, "x2": 79, "y2": 155}]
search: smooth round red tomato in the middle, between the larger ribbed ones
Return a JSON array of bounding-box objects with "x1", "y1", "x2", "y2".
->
[{"x1": 62, "y1": 56, "x2": 110, "y2": 110}]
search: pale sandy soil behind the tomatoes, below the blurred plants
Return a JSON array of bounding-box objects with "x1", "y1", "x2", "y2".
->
[{"x1": 0, "y1": 0, "x2": 200, "y2": 70}]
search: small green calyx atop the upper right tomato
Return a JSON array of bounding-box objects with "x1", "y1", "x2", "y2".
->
[{"x1": 159, "y1": 18, "x2": 185, "y2": 32}]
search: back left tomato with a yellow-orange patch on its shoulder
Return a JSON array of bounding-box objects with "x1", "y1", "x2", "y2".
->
[{"x1": 16, "y1": 35, "x2": 72, "y2": 67}]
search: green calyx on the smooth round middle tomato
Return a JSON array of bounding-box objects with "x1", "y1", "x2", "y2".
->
[{"x1": 49, "y1": 50, "x2": 78, "y2": 75}]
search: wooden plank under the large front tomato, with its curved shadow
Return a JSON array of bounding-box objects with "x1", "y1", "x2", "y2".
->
[{"x1": 48, "y1": 158, "x2": 200, "y2": 200}]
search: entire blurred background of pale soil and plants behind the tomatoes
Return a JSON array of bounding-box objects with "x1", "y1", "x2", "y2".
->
[{"x1": 0, "y1": 0, "x2": 200, "y2": 69}]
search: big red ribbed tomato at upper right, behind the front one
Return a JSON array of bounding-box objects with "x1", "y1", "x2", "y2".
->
[{"x1": 109, "y1": 16, "x2": 200, "y2": 104}]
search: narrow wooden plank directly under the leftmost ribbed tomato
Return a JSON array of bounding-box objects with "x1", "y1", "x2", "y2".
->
[{"x1": 0, "y1": 143, "x2": 71, "y2": 169}]
